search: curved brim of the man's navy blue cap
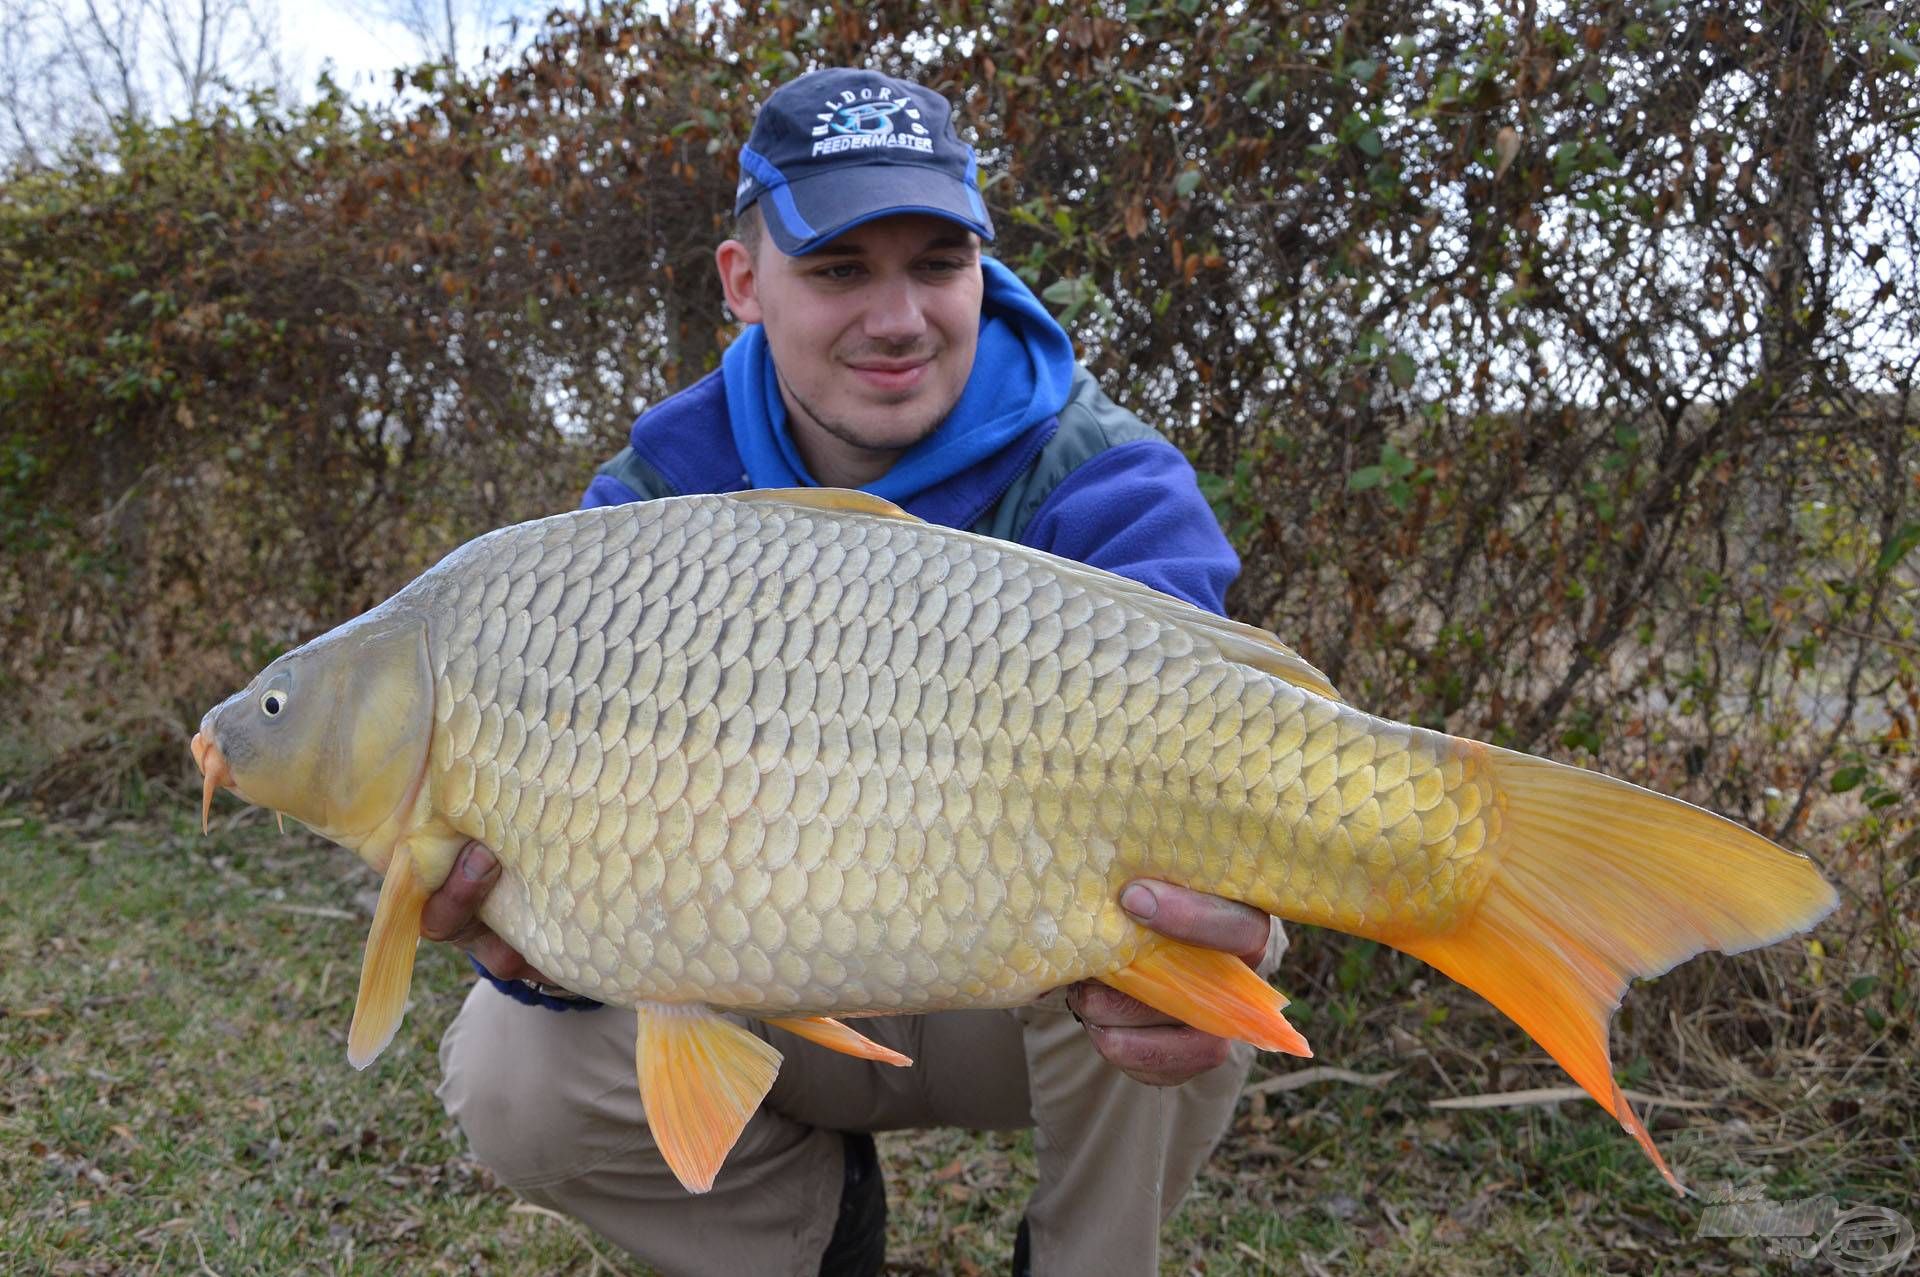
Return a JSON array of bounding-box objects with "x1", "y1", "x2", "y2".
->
[{"x1": 758, "y1": 163, "x2": 993, "y2": 257}]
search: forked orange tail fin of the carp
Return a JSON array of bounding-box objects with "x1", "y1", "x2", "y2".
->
[{"x1": 1392, "y1": 745, "x2": 1837, "y2": 1191}]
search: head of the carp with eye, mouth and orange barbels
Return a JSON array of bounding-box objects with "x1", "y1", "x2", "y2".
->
[{"x1": 192, "y1": 611, "x2": 434, "y2": 864}]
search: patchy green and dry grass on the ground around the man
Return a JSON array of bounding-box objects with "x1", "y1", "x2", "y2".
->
[{"x1": 0, "y1": 807, "x2": 1920, "y2": 1277}]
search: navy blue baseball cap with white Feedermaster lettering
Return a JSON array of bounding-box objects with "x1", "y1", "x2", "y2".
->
[{"x1": 733, "y1": 67, "x2": 993, "y2": 257}]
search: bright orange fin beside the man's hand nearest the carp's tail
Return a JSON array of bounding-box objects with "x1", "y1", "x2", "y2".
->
[{"x1": 1100, "y1": 939, "x2": 1313, "y2": 1058}]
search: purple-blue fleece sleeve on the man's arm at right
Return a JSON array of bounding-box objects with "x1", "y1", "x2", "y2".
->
[{"x1": 1021, "y1": 440, "x2": 1240, "y2": 614}]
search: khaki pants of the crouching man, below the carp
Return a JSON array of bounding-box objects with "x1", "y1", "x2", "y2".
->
[{"x1": 440, "y1": 983, "x2": 1284, "y2": 1277}]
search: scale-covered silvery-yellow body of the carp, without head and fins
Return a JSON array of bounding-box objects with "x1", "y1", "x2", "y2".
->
[{"x1": 417, "y1": 499, "x2": 1498, "y2": 1010}]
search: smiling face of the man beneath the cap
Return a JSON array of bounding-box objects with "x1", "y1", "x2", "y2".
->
[{"x1": 716, "y1": 213, "x2": 983, "y2": 486}]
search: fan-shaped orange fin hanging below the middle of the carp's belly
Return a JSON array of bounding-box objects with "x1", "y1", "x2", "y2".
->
[{"x1": 634, "y1": 1004, "x2": 780, "y2": 1193}]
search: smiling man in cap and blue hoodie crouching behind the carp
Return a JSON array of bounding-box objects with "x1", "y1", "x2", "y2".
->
[{"x1": 422, "y1": 69, "x2": 1279, "y2": 1275}]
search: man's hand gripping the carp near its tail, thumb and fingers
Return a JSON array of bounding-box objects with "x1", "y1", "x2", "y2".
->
[{"x1": 1068, "y1": 878, "x2": 1273, "y2": 1087}]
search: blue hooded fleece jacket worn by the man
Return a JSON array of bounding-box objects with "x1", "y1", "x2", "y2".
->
[{"x1": 474, "y1": 259, "x2": 1240, "y2": 1010}]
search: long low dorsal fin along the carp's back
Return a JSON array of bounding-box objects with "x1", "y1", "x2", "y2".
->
[{"x1": 728, "y1": 488, "x2": 1344, "y2": 701}]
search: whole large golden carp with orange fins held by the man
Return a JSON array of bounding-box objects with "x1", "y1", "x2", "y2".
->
[{"x1": 194, "y1": 490, "x2": 1836, "y2": 1191}]
